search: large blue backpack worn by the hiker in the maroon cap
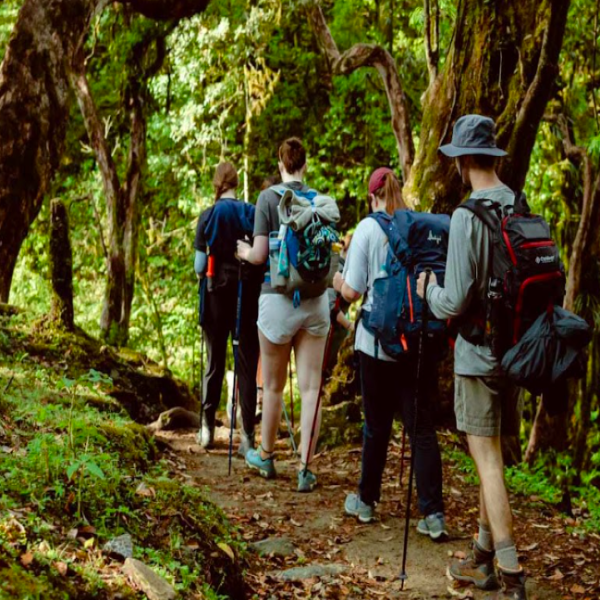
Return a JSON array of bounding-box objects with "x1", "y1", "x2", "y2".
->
[{"x1": 361, "y1": 210, "x2": 450, "y2": 360}]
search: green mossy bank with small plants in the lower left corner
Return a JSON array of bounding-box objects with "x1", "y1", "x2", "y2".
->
[{"x1": 0, "y1": 315, "x2": 244, "y2": 600}]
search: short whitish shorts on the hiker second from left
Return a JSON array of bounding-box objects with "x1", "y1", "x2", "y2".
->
[{"x1": 258, "y1": 293, "x2": 330, "y2": 344}]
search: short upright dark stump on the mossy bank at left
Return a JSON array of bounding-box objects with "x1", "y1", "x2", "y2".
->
[{"x1": 50, "y1": 199, "x2": 75, "y2": 331}]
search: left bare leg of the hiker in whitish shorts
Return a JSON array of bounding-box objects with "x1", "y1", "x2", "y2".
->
[{"x1": 258, "y1": 330, "x2": 291, "y2": 459}]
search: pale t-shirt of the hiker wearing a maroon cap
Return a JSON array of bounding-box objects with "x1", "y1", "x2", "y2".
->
[{"x1": 343, "y1": 212, "x2": 394, "y2": 361}]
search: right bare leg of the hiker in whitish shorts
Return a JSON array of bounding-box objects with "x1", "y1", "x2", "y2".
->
[{"x1": 294, "y1": 330, "x2": 327, "y2": 464}]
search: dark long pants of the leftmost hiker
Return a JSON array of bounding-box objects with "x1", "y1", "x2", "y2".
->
[{"x1": 202, "y1": 281, "x2": 260, "y2": 433}]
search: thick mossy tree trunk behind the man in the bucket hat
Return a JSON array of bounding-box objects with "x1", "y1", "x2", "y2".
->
[{"x1": 404, "y1": 0, "x2": 569, "y2": 212}]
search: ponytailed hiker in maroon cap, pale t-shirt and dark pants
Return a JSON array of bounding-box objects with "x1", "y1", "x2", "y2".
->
[{"x1": 334, "y1": 167, "x2": 447, "y2": 541}]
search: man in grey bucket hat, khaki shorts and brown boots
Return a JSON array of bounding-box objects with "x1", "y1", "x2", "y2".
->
[{"x1": 417, "y1": 115, "x2": 527, "y2": 600}]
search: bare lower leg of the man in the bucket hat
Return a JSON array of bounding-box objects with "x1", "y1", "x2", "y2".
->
[{"x1": 467, "y1": 435, "x2": 513, "y2": 544}]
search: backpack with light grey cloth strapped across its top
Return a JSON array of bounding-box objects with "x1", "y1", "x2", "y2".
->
[{"x1": 269, "y1": 185, "x2": 340, "y2": 307}]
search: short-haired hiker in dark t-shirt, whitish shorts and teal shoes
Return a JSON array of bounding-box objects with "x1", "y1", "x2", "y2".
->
[{"x1": 238, "y1": 138, "x2": 339, "y2": 492}]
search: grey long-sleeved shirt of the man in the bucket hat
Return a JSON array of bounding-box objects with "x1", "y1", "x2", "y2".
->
[{"x1": 427, "y1": 184, "x2": 515, "y2": 377}]
